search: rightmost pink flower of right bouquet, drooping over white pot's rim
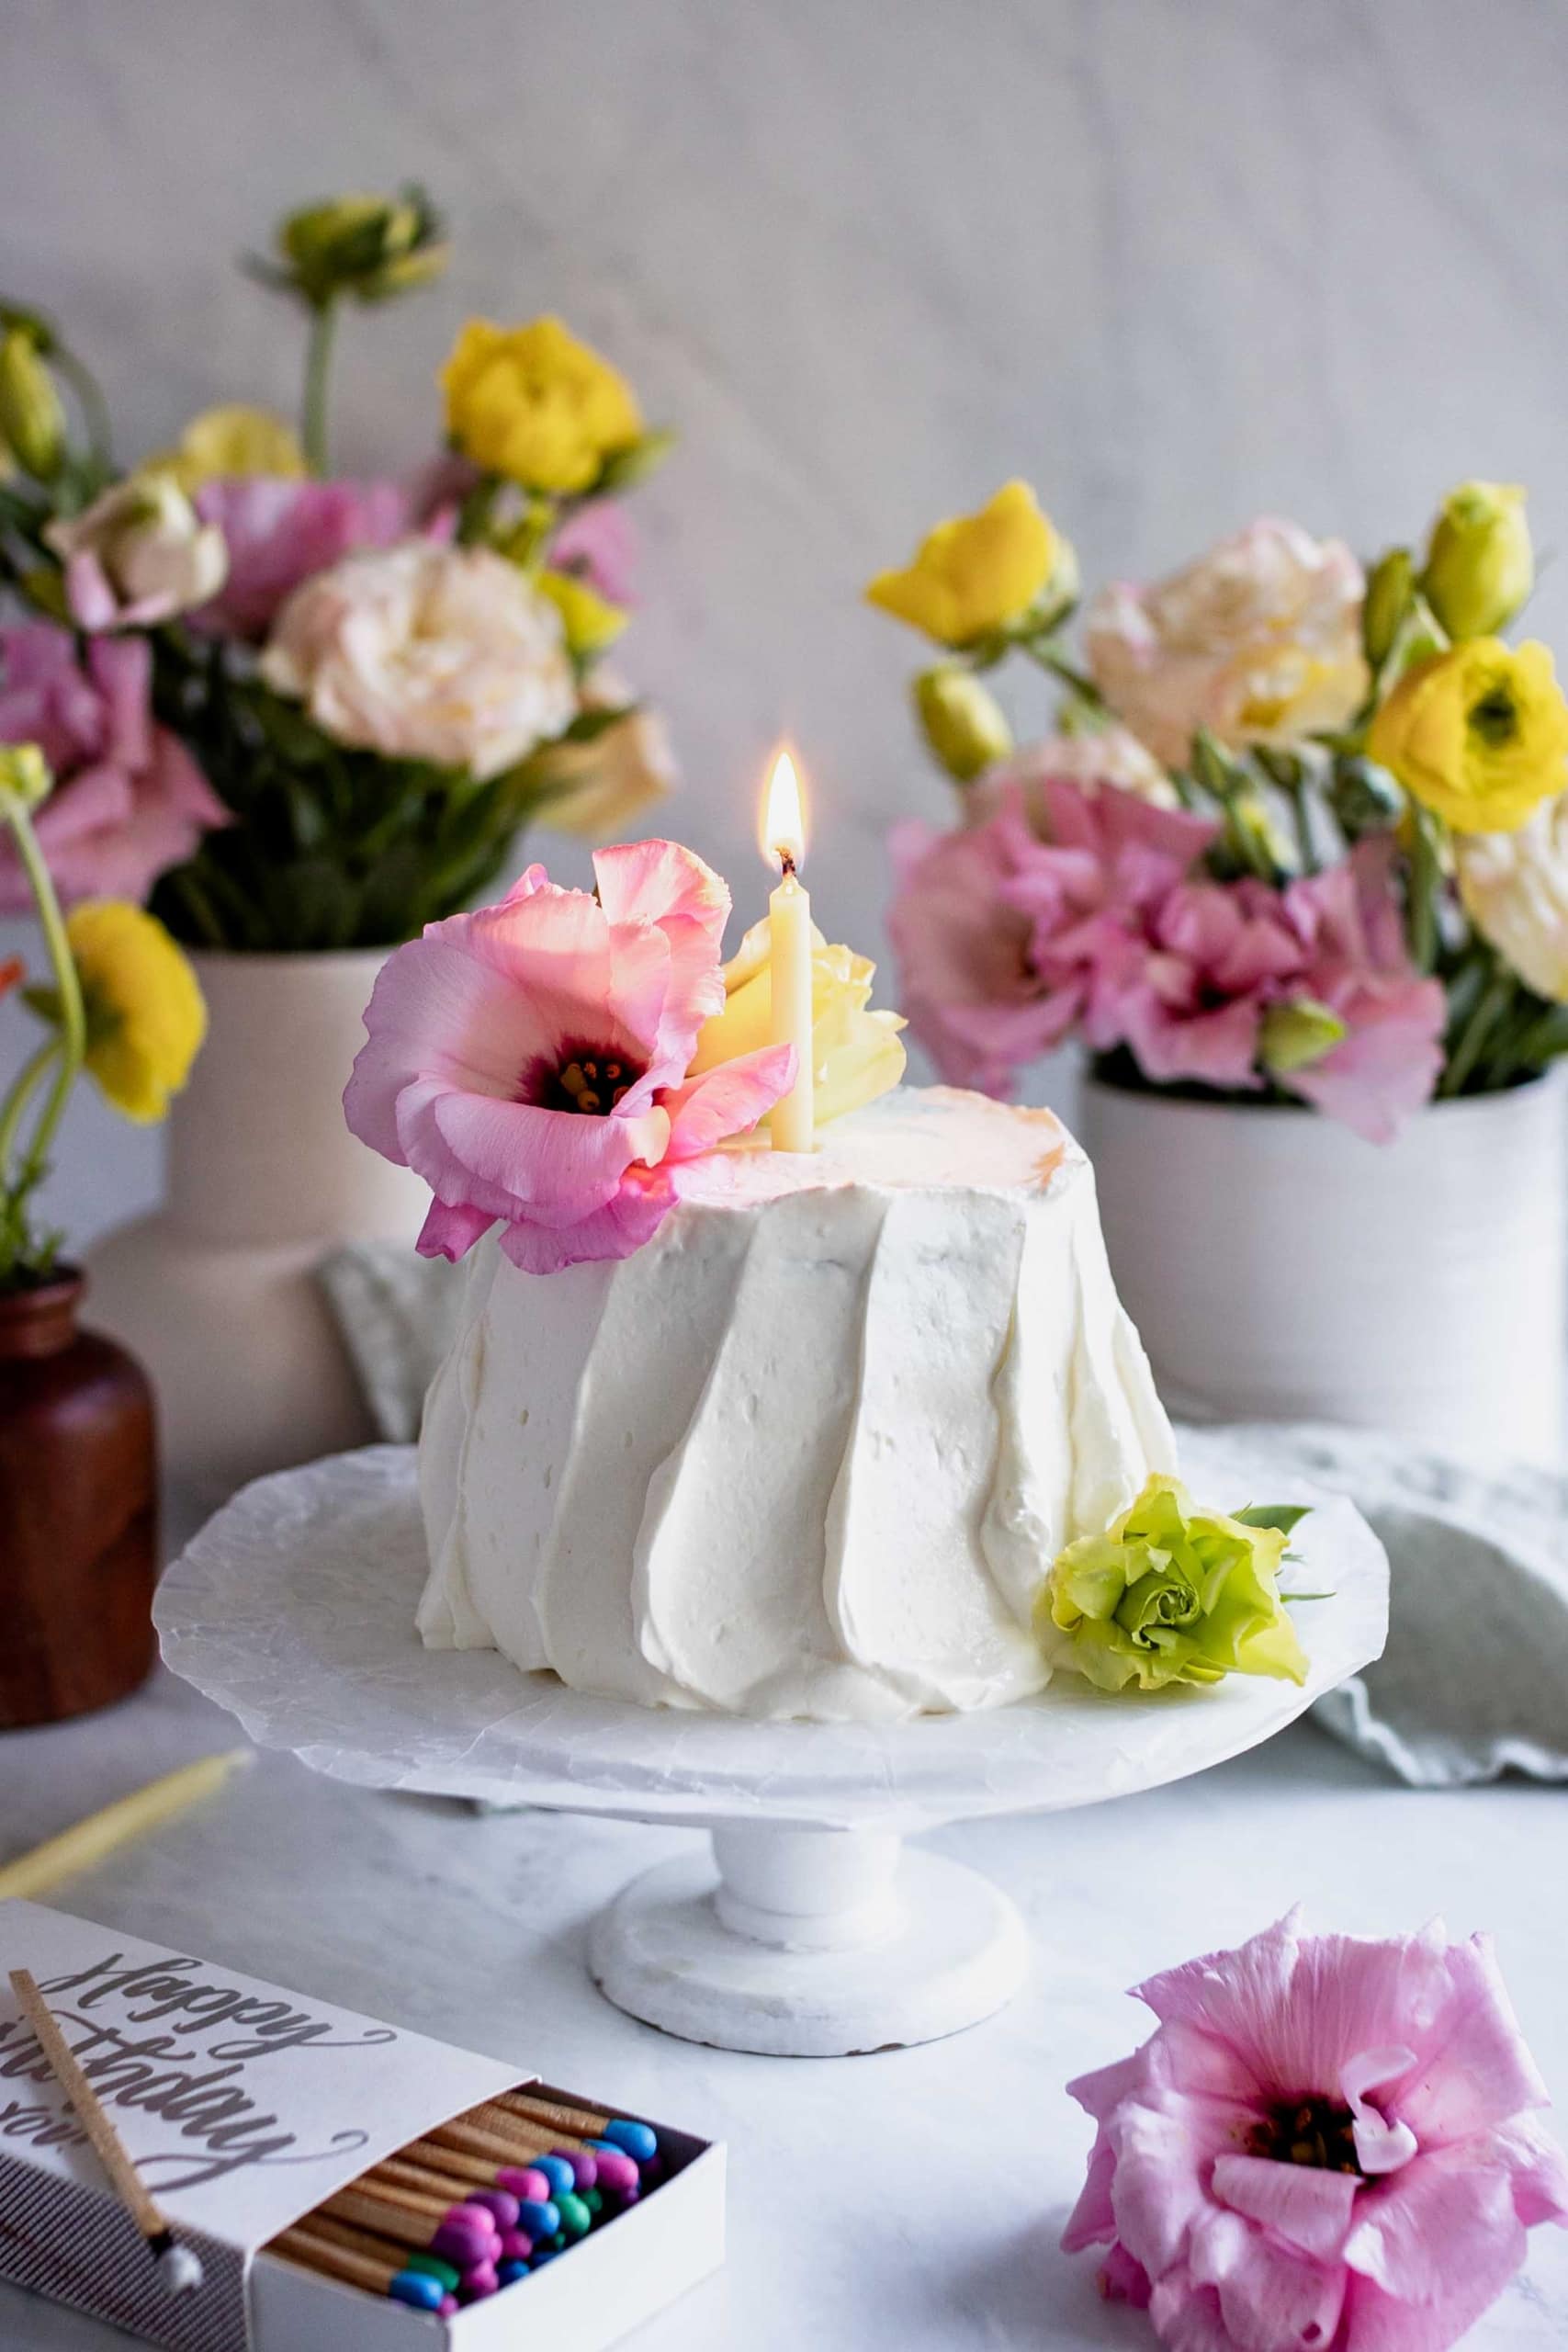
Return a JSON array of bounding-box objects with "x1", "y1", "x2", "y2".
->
[{"x1": 1283, "y1": 840, "x2": 1448, "y2": 1143}]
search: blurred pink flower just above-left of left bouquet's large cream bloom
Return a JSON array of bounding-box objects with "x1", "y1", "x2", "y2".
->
[{"x1": 190, "y1": 473, "x2": 423, "y2": 639}]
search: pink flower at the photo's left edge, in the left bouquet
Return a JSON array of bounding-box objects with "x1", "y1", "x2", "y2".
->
[{"x1": 0, "y1": 621, "x2": 231, "y2": 915}]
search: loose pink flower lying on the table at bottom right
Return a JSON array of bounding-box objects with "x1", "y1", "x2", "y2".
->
[{"x1": 1063, "y1": 1912, "x2": 1568, "y2": 2352}]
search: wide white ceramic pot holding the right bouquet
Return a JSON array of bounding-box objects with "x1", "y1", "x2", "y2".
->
[{"x1": 1081, "y1": 1075, "x2": 1568, "y2": 1461}]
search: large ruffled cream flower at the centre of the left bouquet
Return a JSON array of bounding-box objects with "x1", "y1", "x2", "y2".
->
[{"x1": 261, "y1": 538, "x2": 579, "y2": 778}]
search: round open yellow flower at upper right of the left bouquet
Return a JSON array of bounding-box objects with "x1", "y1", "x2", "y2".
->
[{"x1": 440, "y1": 318, "x2": 642, "y2": 494}]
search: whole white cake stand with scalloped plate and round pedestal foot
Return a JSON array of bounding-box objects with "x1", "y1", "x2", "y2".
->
[{"x1": 157, "y1": 1435, "x2": 1387, "y2": 2058}]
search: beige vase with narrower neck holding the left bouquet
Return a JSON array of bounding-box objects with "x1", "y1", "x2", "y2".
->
[{"x1": 87, "y1": 950, "x2": 428, "y2": 1498}]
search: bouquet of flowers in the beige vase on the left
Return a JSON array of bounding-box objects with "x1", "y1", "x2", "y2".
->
[{"x1": 0, "y1": 188, "x2": 670, "y2": 950}]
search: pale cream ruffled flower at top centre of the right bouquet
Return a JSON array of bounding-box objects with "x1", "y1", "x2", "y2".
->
[{"x1": 1086, "y1": 517, "x2": 1368, "y2": 767}]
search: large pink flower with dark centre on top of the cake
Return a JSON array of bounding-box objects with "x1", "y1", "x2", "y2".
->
[{"x1": 344, "y1": 842, "x2": 795, "y2": 1275}]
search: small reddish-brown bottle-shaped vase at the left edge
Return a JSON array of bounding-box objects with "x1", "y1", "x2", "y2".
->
[{"x1": 0, "y1": 1268, "x2": 157, "y2": 1731}]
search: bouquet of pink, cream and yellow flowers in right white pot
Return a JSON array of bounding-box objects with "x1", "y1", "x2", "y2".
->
[{"x1": 867, "y1": 482, "x2": 1568, "y2": 1141}]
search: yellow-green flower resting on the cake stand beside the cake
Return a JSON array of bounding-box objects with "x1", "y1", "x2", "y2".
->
[{"x1": 1034, "y1": 1475, "x2": 1307, "y2": 1691}]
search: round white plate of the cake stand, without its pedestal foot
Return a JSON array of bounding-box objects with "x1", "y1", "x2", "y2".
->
[{"x1": 155, "y1": 1432, "x2": 1387, "y2": 1830}]
